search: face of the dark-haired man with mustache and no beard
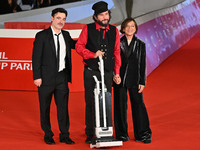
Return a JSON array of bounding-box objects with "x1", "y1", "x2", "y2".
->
[{"x1": 51, "y1": 12, "x2": 66, "y2": 31}]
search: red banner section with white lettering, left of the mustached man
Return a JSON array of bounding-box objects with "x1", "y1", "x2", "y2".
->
[{"x1": 0, "y1": 38, "x2": 37, "y2": 90}]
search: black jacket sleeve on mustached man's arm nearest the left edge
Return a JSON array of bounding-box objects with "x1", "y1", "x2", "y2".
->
[{"x1": 32, "y1": 33, "x2": 44, "y2": 80}]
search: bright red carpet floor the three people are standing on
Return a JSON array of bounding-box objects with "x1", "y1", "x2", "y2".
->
[{"x1": 0, "y1": 32, "x2": 200, "y2": 150}]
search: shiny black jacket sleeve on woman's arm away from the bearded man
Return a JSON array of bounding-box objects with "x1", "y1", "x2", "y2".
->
[{"x1": 139, "y1": 42, "x2": 146, "y2": 86}]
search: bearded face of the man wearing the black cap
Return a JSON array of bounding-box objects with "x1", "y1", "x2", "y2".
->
[{"x1": 94, "y1": 11, "x2": 110, "y2": 27}]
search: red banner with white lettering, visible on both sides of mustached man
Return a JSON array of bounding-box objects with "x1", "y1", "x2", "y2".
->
[{"x1": 0, "y1": 38, "x2": 83, "y2": 92}]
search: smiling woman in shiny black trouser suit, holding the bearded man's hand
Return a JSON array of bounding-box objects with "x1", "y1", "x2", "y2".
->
[{"x1": 114, "y1": 18, "x2": 152, "y2": 143}]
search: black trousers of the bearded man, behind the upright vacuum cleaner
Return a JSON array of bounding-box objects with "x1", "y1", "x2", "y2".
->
[{"x1": 84, "y1": 67, "x2": 113, "y2": 136}]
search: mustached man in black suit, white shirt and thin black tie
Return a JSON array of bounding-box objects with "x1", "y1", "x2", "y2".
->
[{"x1": 32, "y1": 8, "x2": 75, "y2": 144}]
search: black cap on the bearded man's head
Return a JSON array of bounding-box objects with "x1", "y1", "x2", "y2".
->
[{"x1": 92, "y1": 1, "x2": 108, "y2": 15}]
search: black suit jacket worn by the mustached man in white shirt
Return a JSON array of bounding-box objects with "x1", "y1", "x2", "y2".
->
[{"x1": 32, "y1": 27, "x2": 75, "y2": 85}]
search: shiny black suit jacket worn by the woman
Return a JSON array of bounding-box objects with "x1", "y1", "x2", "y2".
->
[{"x1": 117, "y1": 36, "x2": 146, "y2": 88}]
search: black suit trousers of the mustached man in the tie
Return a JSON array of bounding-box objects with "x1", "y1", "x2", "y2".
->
[{"x1": 38, "y1": 71, "x2": 69, "y2": 137}]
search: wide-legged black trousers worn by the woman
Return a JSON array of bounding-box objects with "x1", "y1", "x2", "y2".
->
[{"x1": 114, "y1": 86, "x2": 151, "y2": 139}]
